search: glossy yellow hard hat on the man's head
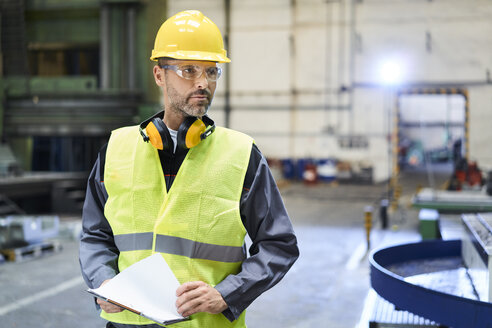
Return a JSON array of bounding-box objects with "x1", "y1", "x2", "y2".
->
[{"x1": 150, "y1": 10, "x2": 231, "y2": 63}]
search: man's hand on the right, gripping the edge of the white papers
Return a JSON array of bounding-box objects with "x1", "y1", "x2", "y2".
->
[{"x1": 176, "y1": 281, "x2": 227, "y2": 317}]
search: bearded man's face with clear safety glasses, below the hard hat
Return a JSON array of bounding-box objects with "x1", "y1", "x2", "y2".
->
[{"x1": 161, "y1": 60, "x2": 217, "y2": 117}]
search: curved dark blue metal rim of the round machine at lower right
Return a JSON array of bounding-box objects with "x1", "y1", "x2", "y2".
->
[{"x1": 369, "y1": 240, "x2": 492, "y2": 328}]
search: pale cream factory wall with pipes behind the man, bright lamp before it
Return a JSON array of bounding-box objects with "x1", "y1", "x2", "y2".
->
[{"x1": 163, "y1": 0, "x2": 492, "y2": 181}]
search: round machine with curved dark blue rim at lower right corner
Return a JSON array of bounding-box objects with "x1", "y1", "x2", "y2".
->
[{"x1": 370, "y1": 213, "x2": 492, "y2": 328}]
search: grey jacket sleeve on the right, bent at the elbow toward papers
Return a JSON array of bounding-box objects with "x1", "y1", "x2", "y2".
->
[{"x1": 215, "y1": 146, "x2": 299, "y2": 321}]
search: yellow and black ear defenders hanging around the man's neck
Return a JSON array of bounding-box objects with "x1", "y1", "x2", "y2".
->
[{"x1": 139, "y1": 112, "x2": 215, "y2": 150}]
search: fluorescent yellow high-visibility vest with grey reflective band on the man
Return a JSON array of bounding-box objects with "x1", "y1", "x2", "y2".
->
[{"x1": 101, "y1": 127, "x2": 253, "y2": 328}]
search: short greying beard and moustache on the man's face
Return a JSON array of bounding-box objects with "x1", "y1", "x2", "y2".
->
[{"x1": 166, "y1": 84, "x2": 212, "y2": 117}]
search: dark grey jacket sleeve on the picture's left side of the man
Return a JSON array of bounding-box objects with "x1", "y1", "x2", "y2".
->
[{"x1": 79, "y1": 149, "x2": 119, "y2": 288}]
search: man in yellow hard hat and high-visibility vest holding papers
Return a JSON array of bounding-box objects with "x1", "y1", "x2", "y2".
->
[{"x1": 80, "y1": 11, "x2": 299, "y2": 328}]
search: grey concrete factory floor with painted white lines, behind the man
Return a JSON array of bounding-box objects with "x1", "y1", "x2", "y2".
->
[{"x1": 0, "y1": 170, "x2": 446, "y2": 328}]
